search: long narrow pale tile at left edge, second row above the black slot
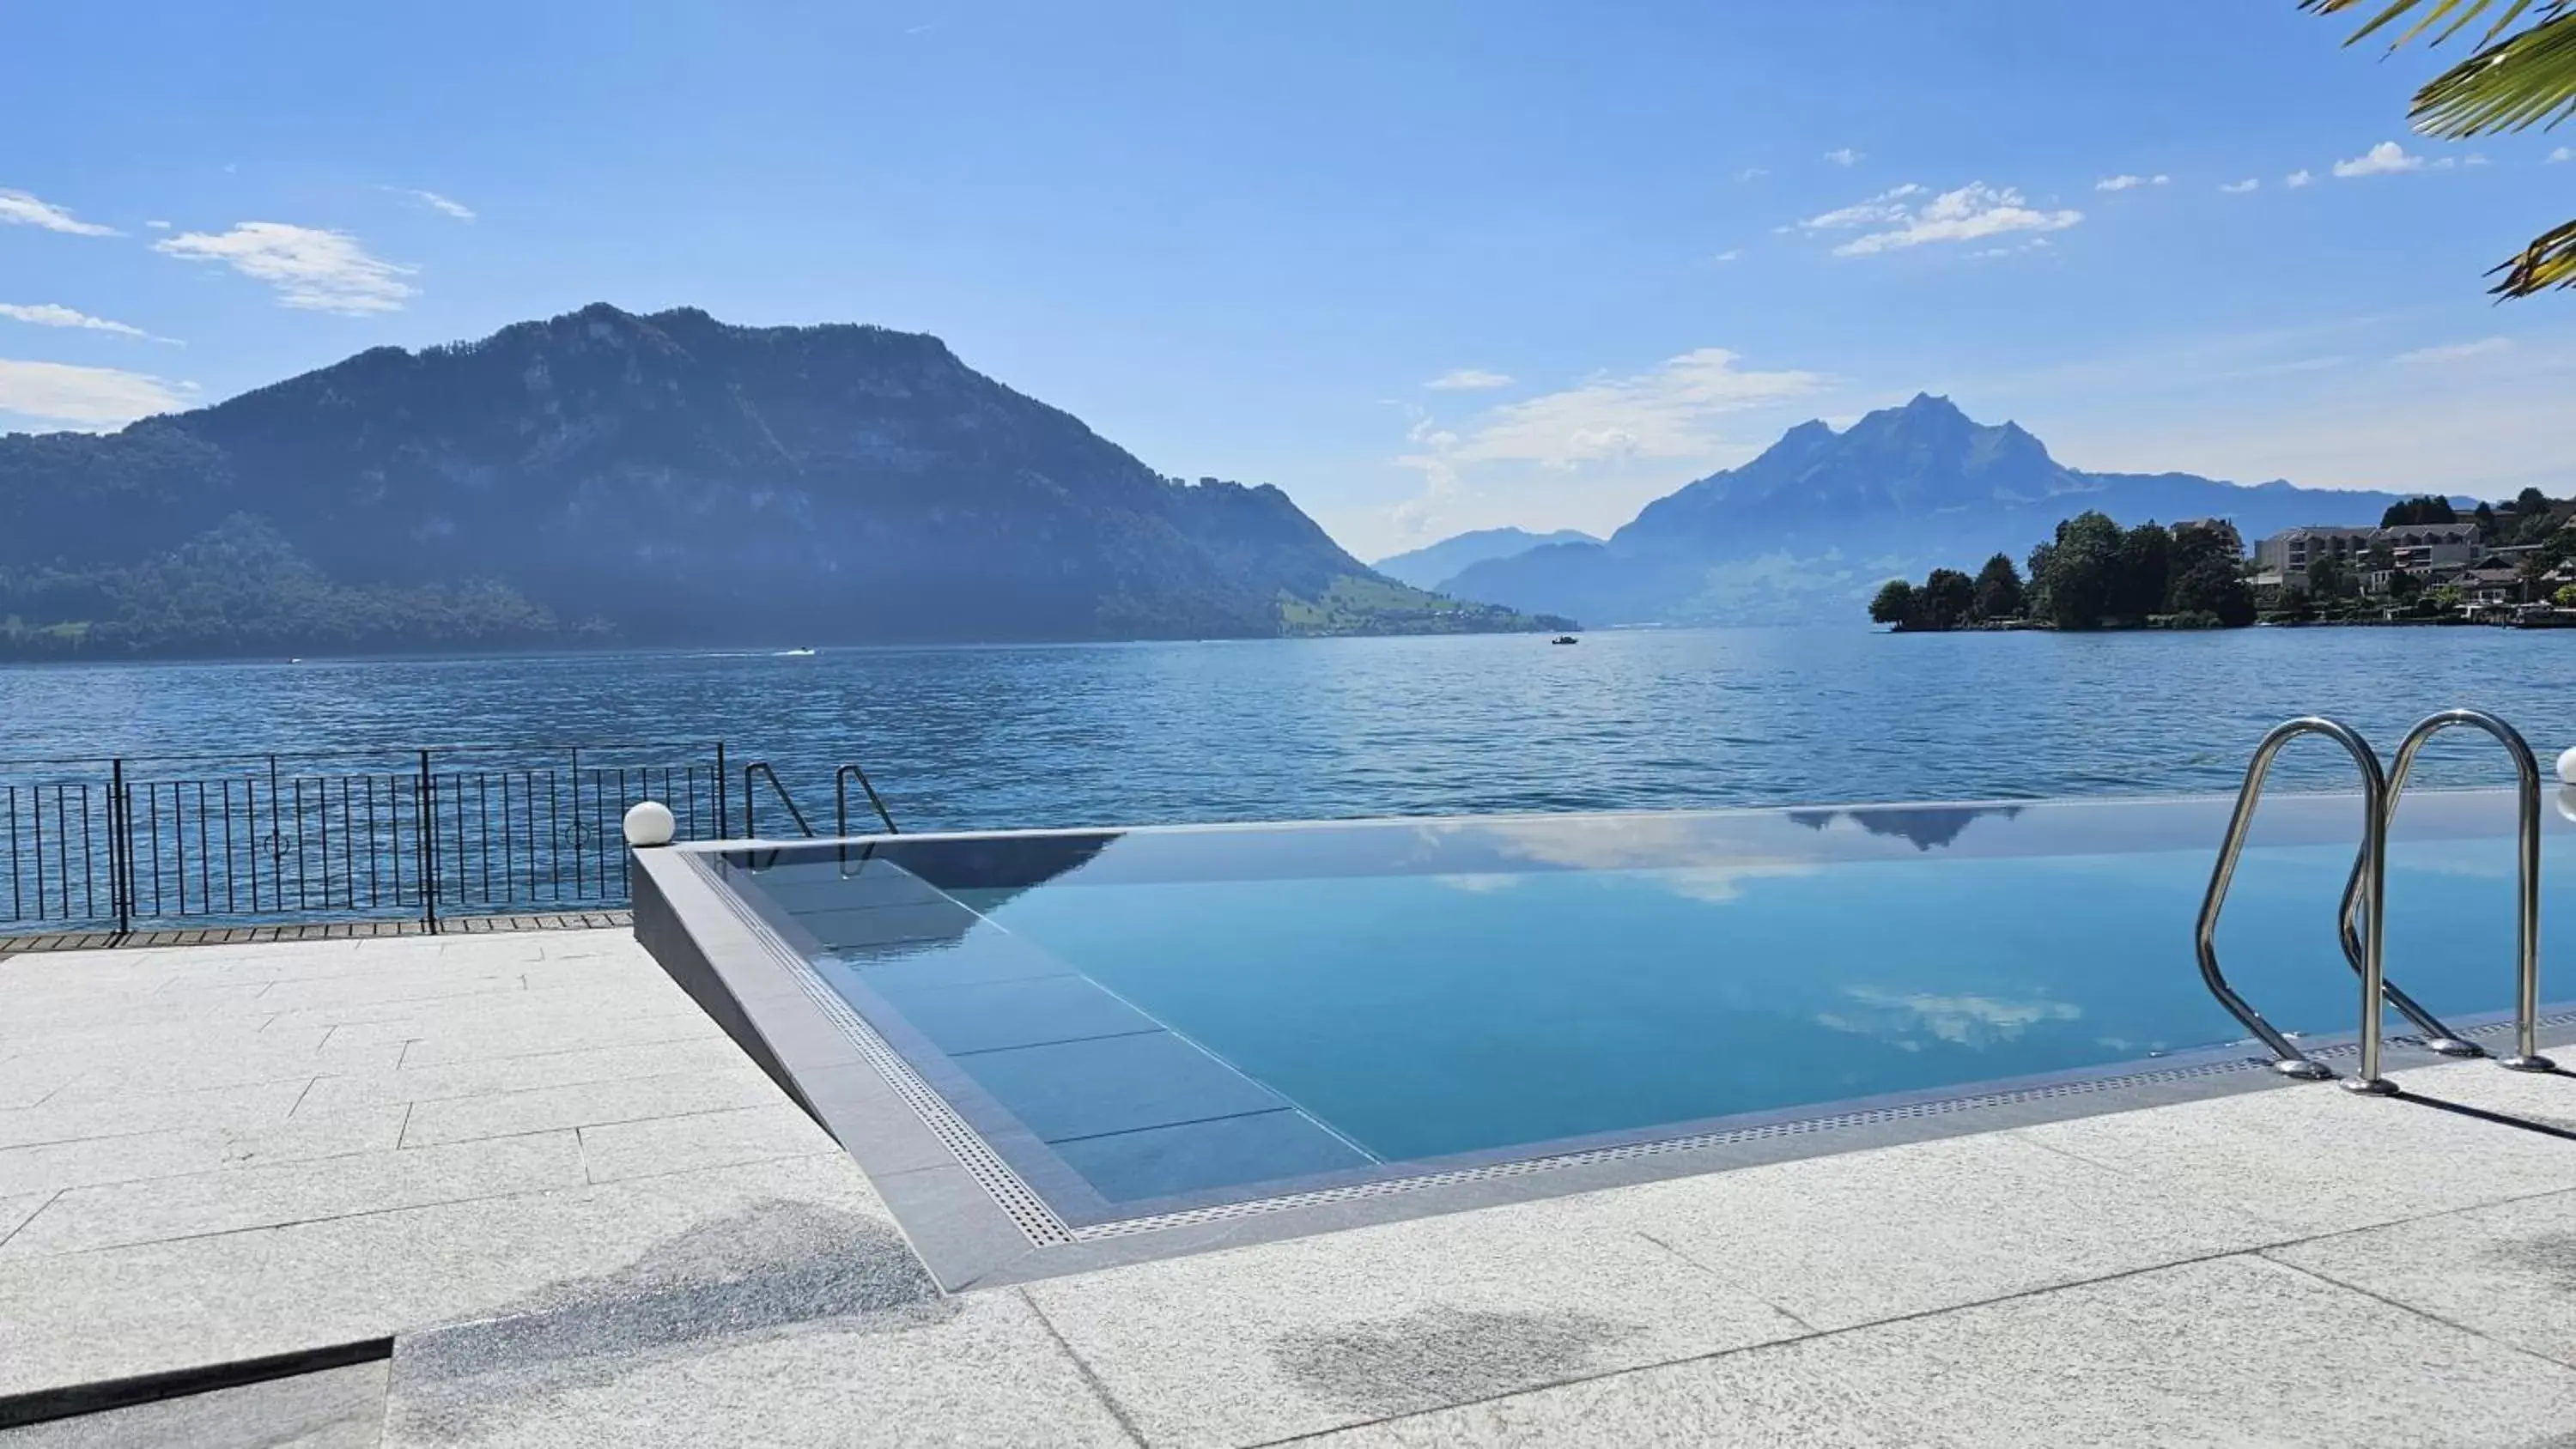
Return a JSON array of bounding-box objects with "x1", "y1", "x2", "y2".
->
[{"x1": 0, "y1": 1132, "x2": 587, "y2": 1256}]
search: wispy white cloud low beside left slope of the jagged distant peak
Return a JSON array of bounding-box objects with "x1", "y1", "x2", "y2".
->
[{"x1": 1404, "y1": 348, "x2": 1824, "y2": 476}]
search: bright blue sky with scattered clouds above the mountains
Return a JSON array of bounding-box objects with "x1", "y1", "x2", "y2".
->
[{"x1": 0, "y1": 0, "x2": 2576, "y2": 556}]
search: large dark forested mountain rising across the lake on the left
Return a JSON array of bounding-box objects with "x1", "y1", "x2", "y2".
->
[{"x1": 0, "y1": 315, "x2": 1561, "y2": 657}]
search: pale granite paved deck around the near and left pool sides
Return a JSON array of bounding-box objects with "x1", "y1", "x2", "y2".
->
[{"x1": 0, "y1": 931, "x2": 2576, "y2": 1449}]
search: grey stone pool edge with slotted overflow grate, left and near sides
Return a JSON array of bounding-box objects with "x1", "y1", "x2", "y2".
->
[{"x1": 634, "y1": 831, "x2": 2576, "y2": 1292}]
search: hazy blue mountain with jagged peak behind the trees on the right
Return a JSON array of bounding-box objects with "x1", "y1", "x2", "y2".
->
[{"x1": 1443, "y1": 394, "x2": 2452, "y2": 626}]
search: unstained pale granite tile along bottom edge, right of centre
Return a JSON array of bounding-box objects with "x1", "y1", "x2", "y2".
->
[{"x1": 1316, "y1": 1256, "x2": 2576, "y2": 1449}]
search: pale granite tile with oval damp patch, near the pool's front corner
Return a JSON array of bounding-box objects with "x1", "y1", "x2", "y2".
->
[{"x1": 1020, "y1": 1202, "x2": 1806, "y2": 1446}]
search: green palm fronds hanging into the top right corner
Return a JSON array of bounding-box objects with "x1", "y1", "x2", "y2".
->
[{"x1": 2300, "y1": 0, "x2": 2576, "y2": 296}]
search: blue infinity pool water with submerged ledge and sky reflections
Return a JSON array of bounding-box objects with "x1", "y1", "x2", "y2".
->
[{"x1": 714, "y1": 792, "x2": 2571, "y2": 1225}]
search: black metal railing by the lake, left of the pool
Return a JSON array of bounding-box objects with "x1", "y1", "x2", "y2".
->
[{"x1": 0, "y1": 743, "x2": 747, "y2": 931}]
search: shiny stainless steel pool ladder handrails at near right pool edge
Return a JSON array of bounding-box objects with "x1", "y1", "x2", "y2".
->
[{"x1": 2195, "y1": 711, "x2": 2555, "y2": 1096}]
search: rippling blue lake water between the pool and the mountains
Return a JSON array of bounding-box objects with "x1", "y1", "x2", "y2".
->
[{"x1": 0, "y1": 628, "x2": 2576, "y2": 828}]
